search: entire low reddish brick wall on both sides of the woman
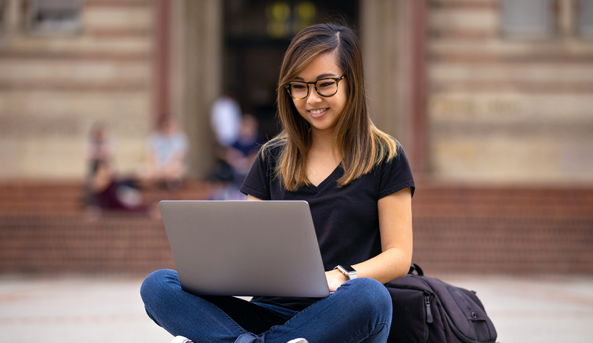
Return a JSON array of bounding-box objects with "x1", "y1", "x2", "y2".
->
[{"x1": 0, "y1": 184, "x2": 593, "y2": 275}]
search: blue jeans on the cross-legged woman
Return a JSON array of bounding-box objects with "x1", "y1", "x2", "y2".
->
[{"x1": 140, "y1": 270, "x2": 392, "y2": 343}]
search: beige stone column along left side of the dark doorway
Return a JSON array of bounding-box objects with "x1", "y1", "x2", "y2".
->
[{"x1": 170, "y1": 0, "x2": 223, "y2": 177}]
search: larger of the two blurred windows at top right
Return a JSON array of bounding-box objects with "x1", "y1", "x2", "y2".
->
[{"x1": 500, "y1": 0, "x2": 556, "y2": 39}]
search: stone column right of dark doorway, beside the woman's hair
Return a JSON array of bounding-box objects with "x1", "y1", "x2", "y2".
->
[{"x1": 360, "y1": 0, "x2": 427, "y2": 176}]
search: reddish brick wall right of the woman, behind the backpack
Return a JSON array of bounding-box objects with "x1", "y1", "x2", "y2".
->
[{"x1": 413, "y1": 184, "x2": 593, "y2": 275}]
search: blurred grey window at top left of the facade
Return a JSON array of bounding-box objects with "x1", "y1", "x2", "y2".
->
[{"x1": 27, "y1": 0, "x2": 82, "y2": 34}]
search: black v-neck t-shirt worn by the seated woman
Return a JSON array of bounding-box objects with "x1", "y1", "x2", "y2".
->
[{"x1": 241, "y1": 142, "x2": 415, "y2": 310}]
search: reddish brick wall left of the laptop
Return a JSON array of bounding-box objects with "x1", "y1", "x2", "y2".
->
[{"x1": 0, "y1": 180, "x2": 209, "y2": 274}]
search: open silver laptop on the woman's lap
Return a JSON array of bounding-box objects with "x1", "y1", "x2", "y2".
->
[{"x1": 159, "y1": 200, "x2": 329, "y2": 297}]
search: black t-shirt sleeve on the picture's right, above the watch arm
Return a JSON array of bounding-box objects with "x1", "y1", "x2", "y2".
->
[{"x1": 378, "y1": 145, "x2": 416, "y2": 199}]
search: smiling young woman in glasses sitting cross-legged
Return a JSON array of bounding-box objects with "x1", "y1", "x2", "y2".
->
[{"x1": 142, "y1": 24, "x2": 414, "y2": 343}]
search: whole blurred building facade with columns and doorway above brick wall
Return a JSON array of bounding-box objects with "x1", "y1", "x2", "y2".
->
[{"x1": 0, "y1": 0, "x2": 593, "y2": 185}]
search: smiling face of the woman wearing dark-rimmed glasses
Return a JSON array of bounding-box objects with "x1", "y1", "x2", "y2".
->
[{"x1": 292, "y1": 52, "x2": 347, "y2": 133}]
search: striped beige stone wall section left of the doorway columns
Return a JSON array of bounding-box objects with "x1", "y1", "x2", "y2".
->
[{"x1": 0, "y1": 0, "x2": 154, "y2": 181}]
